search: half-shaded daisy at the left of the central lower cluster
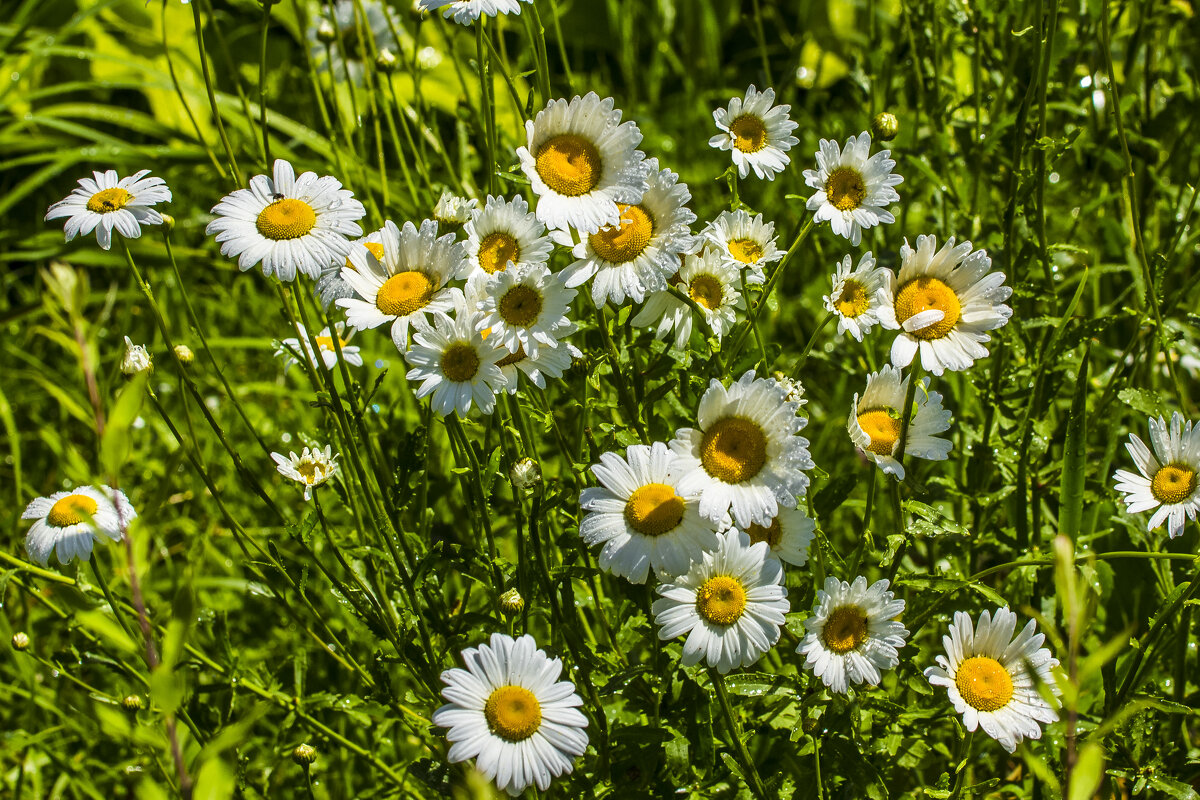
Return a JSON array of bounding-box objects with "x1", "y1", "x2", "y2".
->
[{"x1": 580, "y1": 441, "x2": 716, "y2": 583}]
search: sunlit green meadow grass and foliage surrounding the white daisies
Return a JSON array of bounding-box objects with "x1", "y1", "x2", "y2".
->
[{"x1": 0, "y1": 0, "x2": 1200, "y2": 800}]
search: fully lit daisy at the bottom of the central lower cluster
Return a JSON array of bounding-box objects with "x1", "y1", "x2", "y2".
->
[{"x1": 650, "y1": 529, "x2": 788, "y2": 675}]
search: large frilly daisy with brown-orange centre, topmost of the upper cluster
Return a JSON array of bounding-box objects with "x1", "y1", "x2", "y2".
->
[{"x1": 517, "y1": 92, "x2": 650, "y2": 236}]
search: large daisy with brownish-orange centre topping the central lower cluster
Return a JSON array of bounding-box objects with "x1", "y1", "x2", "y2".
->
[{"x1": 671, "y1": 369, "x2": 814, "y2": 529}]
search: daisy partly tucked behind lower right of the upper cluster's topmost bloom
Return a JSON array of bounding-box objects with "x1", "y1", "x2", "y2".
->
[{"x1": 563, "y1": 158, "x2": 696, "y2": 306}]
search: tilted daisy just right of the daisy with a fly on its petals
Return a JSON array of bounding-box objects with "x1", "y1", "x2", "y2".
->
[{"x1": 337, "y1": 219, "x2": 469, "y2": 353}]
